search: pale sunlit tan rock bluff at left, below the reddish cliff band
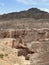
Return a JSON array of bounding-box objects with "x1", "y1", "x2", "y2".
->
[{"x1": 0, "y1": 38, "x2": 16, "y2": 48}]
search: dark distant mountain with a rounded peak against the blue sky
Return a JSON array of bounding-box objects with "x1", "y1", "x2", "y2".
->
[{"x1": 0, "y1": 8, "x2": 49, "y2": 20}]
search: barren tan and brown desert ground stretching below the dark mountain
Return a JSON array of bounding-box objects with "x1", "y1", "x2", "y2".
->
[{"x1": 0, "y1": 7, "x2": 49, "y2": 65}]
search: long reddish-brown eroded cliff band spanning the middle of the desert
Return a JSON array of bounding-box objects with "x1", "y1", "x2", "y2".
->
[{"x1": 0, "y1": 29, "x2": 49, "y2": 41}]
